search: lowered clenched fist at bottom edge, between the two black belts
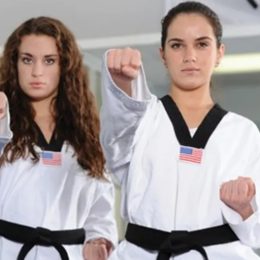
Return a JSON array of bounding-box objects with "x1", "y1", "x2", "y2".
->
[{"x1": 83, "y1": 238, "x2": 112, "y2": 260}]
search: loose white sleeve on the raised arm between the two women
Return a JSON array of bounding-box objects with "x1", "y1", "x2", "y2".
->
[{"x1": 101, "y1": 49, "x2": 152, "y2": 173}]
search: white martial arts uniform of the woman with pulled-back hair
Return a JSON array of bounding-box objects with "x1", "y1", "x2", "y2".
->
[{"x1": 101, "y1": 53, "x2": 260, "y2": 260}]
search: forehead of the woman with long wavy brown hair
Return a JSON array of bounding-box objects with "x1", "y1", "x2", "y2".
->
[{"x1": 19, "y1": 34, "x2": 58, "y2": 55}]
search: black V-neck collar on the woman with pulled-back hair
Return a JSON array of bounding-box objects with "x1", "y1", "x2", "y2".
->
[{"x1": 161, "y1": 95, "x2": 227, "y2": 148}]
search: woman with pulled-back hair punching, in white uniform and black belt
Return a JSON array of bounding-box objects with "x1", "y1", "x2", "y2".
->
[{"x1": 101, "y1": 2, "x2": 260, "y2": 260}]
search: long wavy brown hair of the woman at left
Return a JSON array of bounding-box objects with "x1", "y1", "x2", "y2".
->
[{"x1": 0, "y1": 17, "x2": 105, "y2": 178}]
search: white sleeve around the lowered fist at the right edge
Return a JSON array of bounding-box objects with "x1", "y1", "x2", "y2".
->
[{"x1": 221, "y1": 123, "x2": 260, "y2": 248}]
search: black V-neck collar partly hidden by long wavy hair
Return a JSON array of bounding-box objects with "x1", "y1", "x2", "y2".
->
[{"x1": 34, "y1": 122, "x2": 64, "y2": 152}]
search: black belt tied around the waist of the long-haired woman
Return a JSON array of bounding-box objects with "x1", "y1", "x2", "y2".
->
[{"x1": 0, "y1": 220, "x2": 85, "y2": 260}]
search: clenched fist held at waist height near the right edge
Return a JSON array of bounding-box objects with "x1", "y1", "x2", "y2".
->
[{"x1": 220, "y1": 177, "x2": 255, "y2": 220}]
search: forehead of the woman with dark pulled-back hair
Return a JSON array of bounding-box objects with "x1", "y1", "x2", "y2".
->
[{"x1": 168, "y1": 13, "x2": 215, "y2": 39}]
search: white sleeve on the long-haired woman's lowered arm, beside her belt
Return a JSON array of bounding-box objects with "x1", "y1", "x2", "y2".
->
[{"x1": 84, "y1": 177, "x2": 118, "y2": 247}]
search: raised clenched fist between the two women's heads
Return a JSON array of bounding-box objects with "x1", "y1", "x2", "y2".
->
[{"x1": 107, "y1": 48, "x2": 142, "y2": 96}]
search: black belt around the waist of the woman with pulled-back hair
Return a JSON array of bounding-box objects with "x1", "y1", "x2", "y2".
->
[{"x1": 125, "y1": 223, "x2": 238, "y2": 260}]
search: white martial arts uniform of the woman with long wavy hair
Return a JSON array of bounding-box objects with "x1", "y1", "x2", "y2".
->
[{"x1": 0, "y1": 107, "x2": 117, "y2": 260}]
